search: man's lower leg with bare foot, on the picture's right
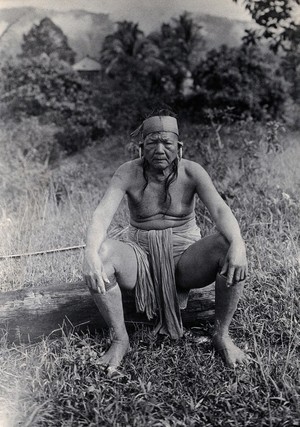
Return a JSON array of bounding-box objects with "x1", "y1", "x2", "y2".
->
[{"x1": 213, "y1": 275, "x2": 246, "y2": 366}]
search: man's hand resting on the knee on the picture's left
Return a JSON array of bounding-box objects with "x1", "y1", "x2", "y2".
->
[{"x1": 83, "y1": 253, "x2": 110, "y2": 294}]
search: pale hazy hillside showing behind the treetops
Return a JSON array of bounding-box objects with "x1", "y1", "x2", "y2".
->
[{"x1": 0, "y1": 7, "x2": 253, "y2": 60}]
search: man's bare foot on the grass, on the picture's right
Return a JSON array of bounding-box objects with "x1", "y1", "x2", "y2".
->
[{"x1": 212, "y1": 335, "x2": 247, "y2": 368}]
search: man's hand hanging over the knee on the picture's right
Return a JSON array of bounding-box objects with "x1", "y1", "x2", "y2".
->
[{"x1": 220, "y1": 239, "x2": 248, "y2": 286}]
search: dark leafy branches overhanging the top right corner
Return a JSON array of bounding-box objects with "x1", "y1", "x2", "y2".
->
[{"x1": 233, "y1": 0, "x2": 300, "y2": 52}]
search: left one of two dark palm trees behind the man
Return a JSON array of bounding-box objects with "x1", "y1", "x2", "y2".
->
[{"x1": 100, "y1": 21, "x2": 162, "y2": 122}]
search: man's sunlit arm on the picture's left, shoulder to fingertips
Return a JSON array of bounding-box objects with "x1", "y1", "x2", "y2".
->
[{"x1": 83, "y1": 163, "x2": 129, "y2": 293}]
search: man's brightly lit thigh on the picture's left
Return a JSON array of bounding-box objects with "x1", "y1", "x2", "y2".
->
[{"x1": 100, "y1": 239, "x2": 137, "y2": 289}]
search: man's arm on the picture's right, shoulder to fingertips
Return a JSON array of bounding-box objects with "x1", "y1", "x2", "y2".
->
[{"x1": 192, "y1": 163, "x2": 248, "y2": 285}]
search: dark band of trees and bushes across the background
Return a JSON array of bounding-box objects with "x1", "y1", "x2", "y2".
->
[{"x1": 1, "y1": 7, "x2": 300, "y2": 153}]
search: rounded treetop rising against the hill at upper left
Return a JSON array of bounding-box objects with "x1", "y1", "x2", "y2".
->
[{"x1": 21, "y1": 18, "x2": 75, "y2": 64}]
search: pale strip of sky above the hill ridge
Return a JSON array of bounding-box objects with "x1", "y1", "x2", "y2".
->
[{"x1": 0, "y1": 0, "x2": 253, "y2": 29}]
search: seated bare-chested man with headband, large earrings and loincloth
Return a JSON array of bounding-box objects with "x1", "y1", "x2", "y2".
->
[{"x1": 84, "y1": 115, "x2": 247, "y2": 371}]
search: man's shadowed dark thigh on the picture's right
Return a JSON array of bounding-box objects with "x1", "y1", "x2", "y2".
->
[{"x1": 176, "y1": 233, "x2": 229, "y2": 289}]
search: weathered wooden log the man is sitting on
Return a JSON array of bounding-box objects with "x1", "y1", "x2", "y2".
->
[{"x1": 0, "y1": 282, "x2": 214, "y2": 343}]
